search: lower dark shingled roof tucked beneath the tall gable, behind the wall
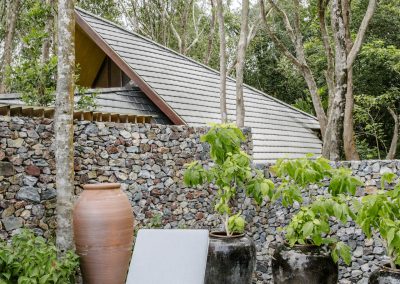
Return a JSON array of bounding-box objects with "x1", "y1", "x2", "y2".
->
[{"x1": 0, "y1": 86, "x2": 171, "y2": 124}]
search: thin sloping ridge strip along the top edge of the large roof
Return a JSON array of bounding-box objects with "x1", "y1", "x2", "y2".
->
[{"x1": 75, "y1": 7, "x2": 318, "y2": 121}]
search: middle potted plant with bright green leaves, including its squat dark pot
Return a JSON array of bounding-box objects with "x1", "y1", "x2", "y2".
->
[{"x1": 272, "y1": 156, "x2": 362, "y2": 283}]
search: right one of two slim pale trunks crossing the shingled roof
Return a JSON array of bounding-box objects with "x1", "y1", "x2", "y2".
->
[{"x1": 236, "y1": 0, "x2": 249, "y2": 127}]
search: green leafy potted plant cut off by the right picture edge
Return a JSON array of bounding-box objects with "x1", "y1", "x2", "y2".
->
[{"x1": 357, "y1": 173, "x2": 400, "y2": 284}]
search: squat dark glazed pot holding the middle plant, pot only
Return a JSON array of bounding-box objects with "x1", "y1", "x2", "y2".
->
[{"x1": 272, "y1": 245, "x2": 338, "y2": 284}]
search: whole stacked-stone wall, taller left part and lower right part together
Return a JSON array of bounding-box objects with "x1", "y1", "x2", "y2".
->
[{"x1": 0, "y1": 116, "x2": 400, "y2": 283}]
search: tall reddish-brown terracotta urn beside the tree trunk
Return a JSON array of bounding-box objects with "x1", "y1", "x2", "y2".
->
[{"x1": 73, "y1": 183, "x2": 133, "y2": 284}]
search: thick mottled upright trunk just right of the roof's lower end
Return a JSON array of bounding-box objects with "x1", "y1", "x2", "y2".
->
[{"x1": 322, "y1": 0, "x2": 347, "y2": 161}]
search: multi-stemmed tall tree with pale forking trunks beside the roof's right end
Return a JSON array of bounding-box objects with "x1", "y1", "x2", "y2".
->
[{"x1": 260, "y1": 0, "x2": 376, "y2": 160}]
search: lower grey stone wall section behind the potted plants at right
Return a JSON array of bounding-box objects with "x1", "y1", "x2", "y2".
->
[{"x1": 252, "y1": 160, "x2": 400, "y2": 284}]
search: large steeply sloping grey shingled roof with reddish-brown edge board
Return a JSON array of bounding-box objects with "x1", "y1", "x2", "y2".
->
[{"x1": 76, "y1": 9, "x2": 322, "y2": 162}]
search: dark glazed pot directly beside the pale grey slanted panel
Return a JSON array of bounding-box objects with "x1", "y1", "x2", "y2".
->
[{"x1": 205, "y1": 232, "x2": 256, "y2": 284}]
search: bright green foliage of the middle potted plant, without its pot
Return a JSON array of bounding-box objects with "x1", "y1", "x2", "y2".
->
[{"x1": 272, "y1": 155, "x2": 362, "y2": 264}]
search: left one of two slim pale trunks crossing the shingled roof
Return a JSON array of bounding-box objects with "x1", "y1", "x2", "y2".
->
[{"x1": 217, "y1": 0, "x2": 228, "y2": 123}]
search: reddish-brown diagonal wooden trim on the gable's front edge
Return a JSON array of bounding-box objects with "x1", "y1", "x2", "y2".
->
[{"x1": 75, "y1": 11, "x2": 186, "y2": 125}]
